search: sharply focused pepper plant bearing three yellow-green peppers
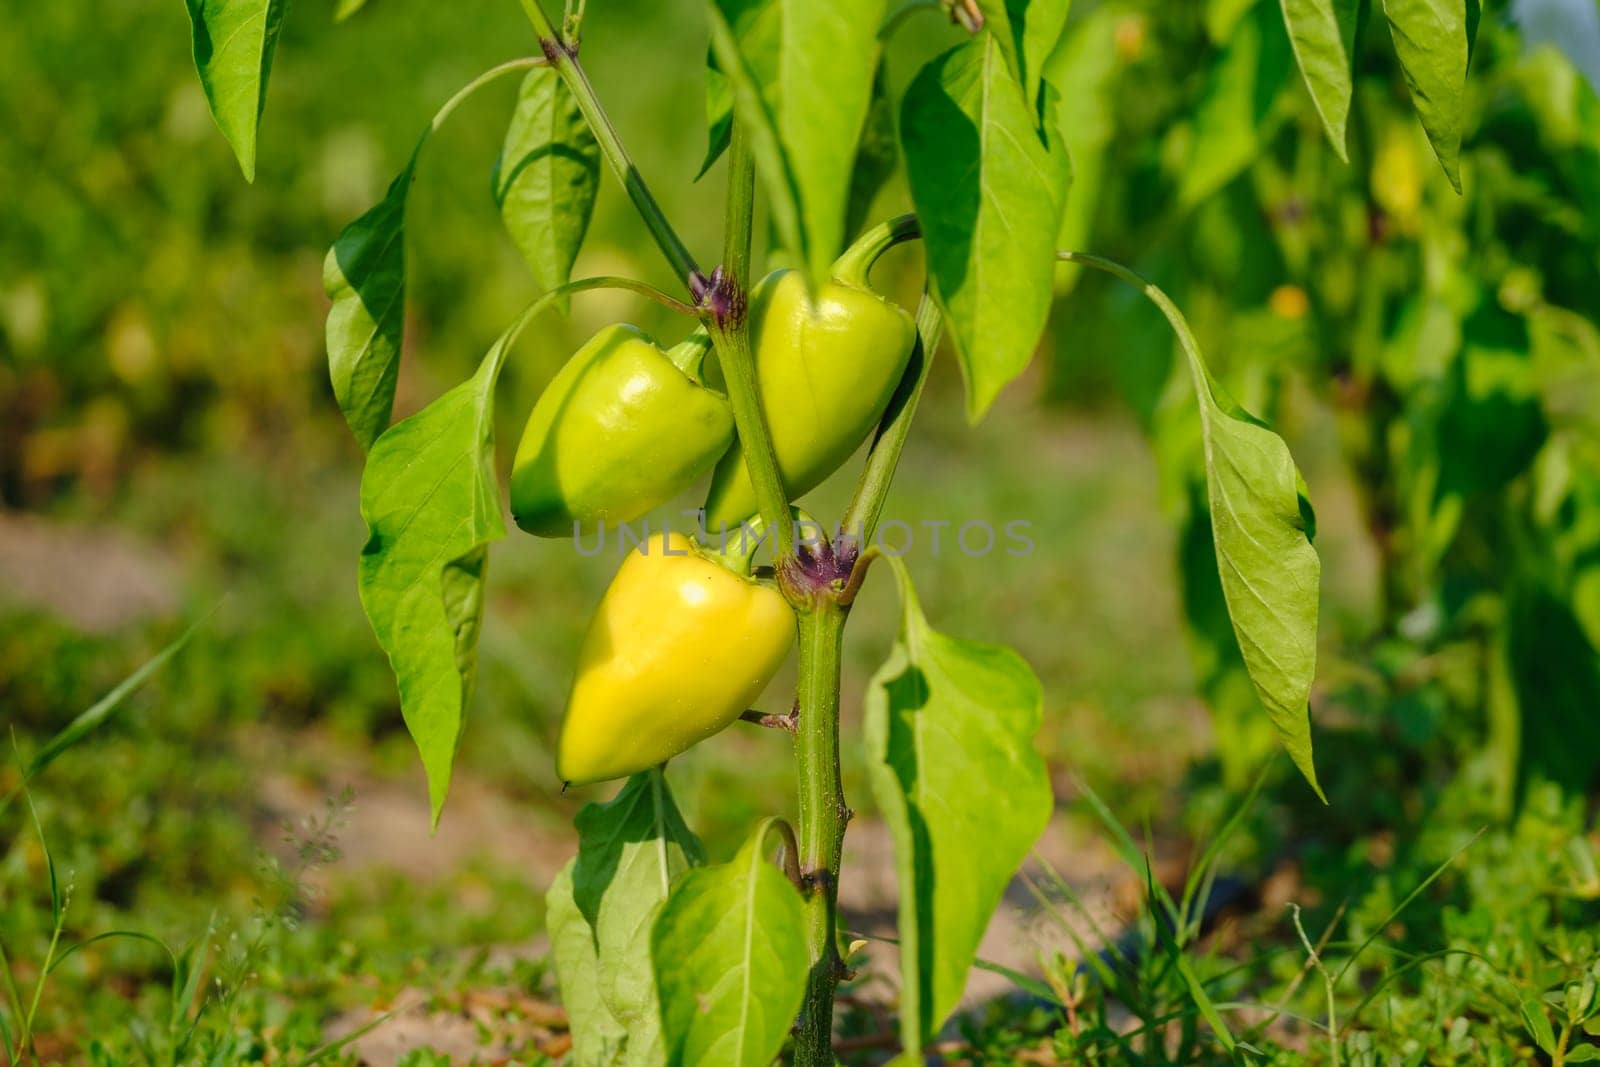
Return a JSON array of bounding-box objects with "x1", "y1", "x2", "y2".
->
[{"x1": 189, "y1": 0, "x2": 1478, "y2": 1064}]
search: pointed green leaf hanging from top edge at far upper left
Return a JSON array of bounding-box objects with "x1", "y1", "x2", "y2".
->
[{"x1": 186, "y1": 0, "x2": 288, "y2": 181}]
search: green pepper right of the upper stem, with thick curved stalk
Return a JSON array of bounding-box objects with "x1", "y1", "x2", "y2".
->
[{"x1": 706, "y1": 218, "x2": 917, "y2": 534}]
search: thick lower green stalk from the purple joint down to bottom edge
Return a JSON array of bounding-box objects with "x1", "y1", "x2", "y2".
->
[{"x1": 794, "y1": 604, "x2": 850, "y2": 1067}]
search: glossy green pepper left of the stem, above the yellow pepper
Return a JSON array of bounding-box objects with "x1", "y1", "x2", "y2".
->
[{"x1": 510, "y1": 323, "x2": 733, "y2": 537}]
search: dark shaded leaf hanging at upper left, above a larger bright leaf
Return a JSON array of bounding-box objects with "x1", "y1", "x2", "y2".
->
[{"x1": 322, "y1": 144, "x2": 427, "y2": 450}]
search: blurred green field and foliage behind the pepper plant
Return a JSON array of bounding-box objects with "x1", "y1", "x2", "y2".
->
[{"x1": 9, "y1": 0, "x2": 1600, "y2": 1064}]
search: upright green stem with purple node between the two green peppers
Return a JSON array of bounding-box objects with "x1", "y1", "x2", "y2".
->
[{"x1": 701, "y1": 122, "x2": 795, "y2": 563}]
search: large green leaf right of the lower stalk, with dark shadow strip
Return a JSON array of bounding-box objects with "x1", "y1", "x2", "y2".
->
[{"x1": 866, "y1": 557, "x2": 1053, "y2": 1049}]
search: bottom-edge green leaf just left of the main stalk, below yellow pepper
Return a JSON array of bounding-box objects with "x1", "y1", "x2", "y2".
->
[{"x1": 651, "y1": 819, "x2": 811, "y2": 1067}]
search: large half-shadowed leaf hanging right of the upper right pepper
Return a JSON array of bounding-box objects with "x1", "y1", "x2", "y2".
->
[{"x1": 901, "y1": 34, "x2": 1072, "y2": 422}]
